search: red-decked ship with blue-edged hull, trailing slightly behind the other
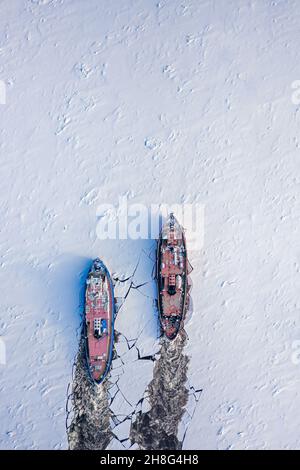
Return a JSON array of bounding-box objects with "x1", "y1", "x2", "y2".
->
[{"x1": 84, "y1": 259, "x2": 115, "y2": 385}]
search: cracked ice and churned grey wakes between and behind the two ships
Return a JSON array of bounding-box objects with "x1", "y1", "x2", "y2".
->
[{"x1": 67, "y1": 251, "x2": 201, "y2": 449}]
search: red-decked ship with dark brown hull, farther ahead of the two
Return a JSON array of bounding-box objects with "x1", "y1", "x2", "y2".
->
[{"x1": 157, "y1": 214, "x2": 188, "y2": 340}]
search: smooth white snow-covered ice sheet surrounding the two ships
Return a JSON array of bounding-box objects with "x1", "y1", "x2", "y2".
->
[{"x1": 0, "y1": 0, "x2": 300, "y2": 449}]
